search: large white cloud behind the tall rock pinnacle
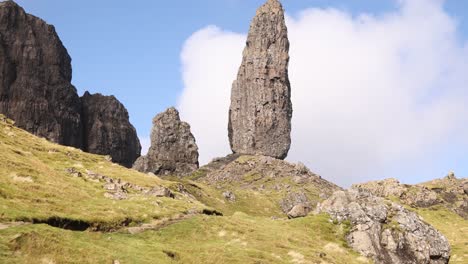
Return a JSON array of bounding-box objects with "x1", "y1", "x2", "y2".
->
[{"x1": 179, "y1": 0, "x2": 468, "y2": 185}]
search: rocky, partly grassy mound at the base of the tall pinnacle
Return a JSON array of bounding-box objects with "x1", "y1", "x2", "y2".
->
[{"x1": 191, "y1": 154, "x2": 341, "y2": 218}]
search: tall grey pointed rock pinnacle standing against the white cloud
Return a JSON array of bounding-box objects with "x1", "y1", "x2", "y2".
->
[{"x1": 228, "y1": 0, "x2": 292, "y2": 159}]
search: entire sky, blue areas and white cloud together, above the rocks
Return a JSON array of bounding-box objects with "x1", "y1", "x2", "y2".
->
[{"x1": 8, "y1": 0, "x2": 468, "y2": 186}]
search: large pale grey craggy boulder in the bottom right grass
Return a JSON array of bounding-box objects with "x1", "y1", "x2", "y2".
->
[{"x1": 317, "y1": 189, "x2": 450, "y2": 264}]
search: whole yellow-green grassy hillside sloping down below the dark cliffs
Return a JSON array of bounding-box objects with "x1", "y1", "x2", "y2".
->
[{"x1": 0, "y1": 117, "x2": 368, "y2": 263}]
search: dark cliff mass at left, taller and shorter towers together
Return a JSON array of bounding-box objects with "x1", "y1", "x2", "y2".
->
[{"x1": 0, "y1": 1, "x2": 140, "y2": 167}]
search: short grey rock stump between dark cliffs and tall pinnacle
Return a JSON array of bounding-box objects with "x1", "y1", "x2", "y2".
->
[{"x1": 133, "y1": 108, "x2": 198, "y2": 176}]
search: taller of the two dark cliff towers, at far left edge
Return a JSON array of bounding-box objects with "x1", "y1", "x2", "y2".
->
[{"x1": 0, "y1": 1, "x2": 82, "y2": 148}]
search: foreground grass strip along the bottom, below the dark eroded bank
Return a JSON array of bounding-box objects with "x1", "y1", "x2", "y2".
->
[{"x1": 0, "y1": 213, "x2": 365, "y2": 263}]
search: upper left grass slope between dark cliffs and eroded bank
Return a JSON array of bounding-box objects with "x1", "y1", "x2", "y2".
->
[{"x1": 0, "y1": 116, "x2": 205, "y2": 226}]
